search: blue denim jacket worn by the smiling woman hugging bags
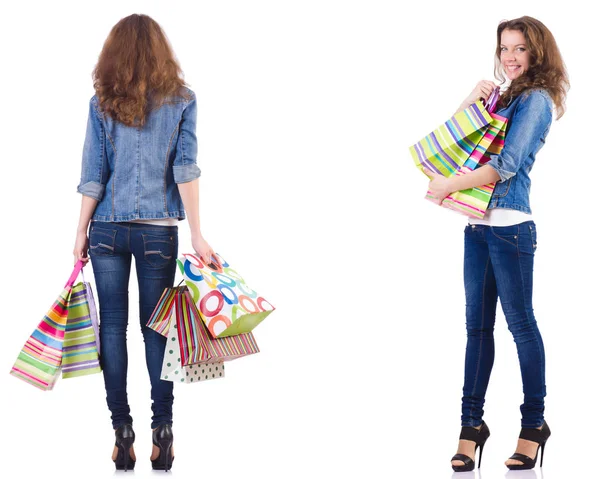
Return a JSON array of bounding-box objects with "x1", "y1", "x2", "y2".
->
[{"x1": 486, "y1": 89, "x2": 552, "y2": 213}]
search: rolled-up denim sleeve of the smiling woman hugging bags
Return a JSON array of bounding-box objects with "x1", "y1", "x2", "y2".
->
[{"x1": 486, "y1": 90, "x2": 552, "y2": 182}]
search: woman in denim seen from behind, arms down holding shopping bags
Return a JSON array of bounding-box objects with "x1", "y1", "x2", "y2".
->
[{"x1": 73, "y1": 14, "x2": 219, "y2": 470}]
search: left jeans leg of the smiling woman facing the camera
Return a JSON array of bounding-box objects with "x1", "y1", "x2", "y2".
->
[{"x1": 461, "y1": 225, "x2": 498, "y2": 427}]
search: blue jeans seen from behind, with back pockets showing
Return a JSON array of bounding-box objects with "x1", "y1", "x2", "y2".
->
[{"x1": 89, "y1": 221, "x2": 178, "y2": 429}]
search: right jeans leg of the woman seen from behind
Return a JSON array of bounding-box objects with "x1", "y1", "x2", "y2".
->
[{"x1": 130, "y1": 223, "x2": 178, "y2": 429}]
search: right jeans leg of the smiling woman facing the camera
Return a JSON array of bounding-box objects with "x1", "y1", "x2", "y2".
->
[{"x1": 489, "y1": 221, "x2": 546, "y2": 427}]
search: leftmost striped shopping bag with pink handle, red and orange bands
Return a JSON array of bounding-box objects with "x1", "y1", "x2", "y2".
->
[{"x1": 10, "y1": 261, "x2": 83, "y2": 391}]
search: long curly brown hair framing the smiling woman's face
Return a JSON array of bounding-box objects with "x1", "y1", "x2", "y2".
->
[{"x1": 495, "y1": 16, "x2": 570, "y2": 119}]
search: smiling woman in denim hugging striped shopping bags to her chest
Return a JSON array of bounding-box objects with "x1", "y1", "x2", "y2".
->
[{"x1": 428, "y1": 17, "x2": 569, "y2": 471}]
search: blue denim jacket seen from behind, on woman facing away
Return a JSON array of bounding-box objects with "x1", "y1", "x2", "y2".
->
[{"x1": 77, "y1": 88, "x2": 200, "y2": 222}]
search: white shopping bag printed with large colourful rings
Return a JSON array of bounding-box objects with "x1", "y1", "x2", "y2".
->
[{"x1": 177, "y1": 254, "x2": 275, "y2": 338}]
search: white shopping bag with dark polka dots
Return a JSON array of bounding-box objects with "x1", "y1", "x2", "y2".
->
[{"x1": 160, "y1": 316, "x2": 225, "y2": 383}]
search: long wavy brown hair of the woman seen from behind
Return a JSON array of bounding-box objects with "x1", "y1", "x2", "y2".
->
[{"x1": 92, "y1": 14, "x2": 189, "y2": 126}]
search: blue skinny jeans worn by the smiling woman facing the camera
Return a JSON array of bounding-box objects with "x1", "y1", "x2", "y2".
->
[{"x1": 462, "y1": 221, "x2": 546, "y2": 427}]
